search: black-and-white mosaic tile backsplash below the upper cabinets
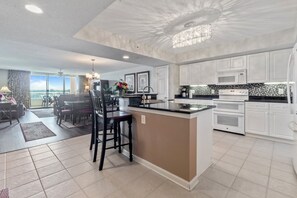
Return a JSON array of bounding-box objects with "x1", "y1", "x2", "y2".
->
[{"x1": 188, "y1": 83, "x2": 287, "y2": 97}]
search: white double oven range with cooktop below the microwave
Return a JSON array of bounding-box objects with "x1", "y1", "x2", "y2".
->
[{"x1": 213, "y1": 89, "x2": 248, "y2": 135}]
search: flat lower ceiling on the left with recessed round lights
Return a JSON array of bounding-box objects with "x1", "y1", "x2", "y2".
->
[{"x1": 0, "y1": 0, "x2": 167, "y2": 74}]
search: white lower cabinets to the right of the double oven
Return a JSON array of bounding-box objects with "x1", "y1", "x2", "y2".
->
[{"x1": 245, "y1": 102, "x2": 294, "y2": 140}]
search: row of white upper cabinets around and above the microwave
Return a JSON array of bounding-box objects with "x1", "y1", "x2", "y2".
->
[{"x1": 180, "y1": 49, "x2": 291, "y2": 85}]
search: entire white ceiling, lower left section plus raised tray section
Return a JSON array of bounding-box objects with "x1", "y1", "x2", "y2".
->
[{"x1": 0, "y1": 0, "x2": 297, "y2": 74}]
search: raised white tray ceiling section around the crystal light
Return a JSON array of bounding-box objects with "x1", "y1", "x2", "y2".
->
[{"x1": 89, "y1": 0, "x2": 297, "y2": 54}]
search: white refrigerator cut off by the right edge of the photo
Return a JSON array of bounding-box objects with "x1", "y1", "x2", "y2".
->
[{"x1": 287, "y1": 43, "x2": 297, "y2": 174}]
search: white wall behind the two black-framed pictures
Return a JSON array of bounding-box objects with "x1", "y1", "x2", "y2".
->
[{"x1": 100, "y1": 66, "x2": 157, "y2": 91}]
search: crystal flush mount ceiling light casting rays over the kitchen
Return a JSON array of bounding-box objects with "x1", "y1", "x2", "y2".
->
[{"x1": 172, "y1": 22, "x2": 212, "y2": 48}]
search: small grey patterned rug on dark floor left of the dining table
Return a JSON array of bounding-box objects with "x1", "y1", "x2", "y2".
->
[{"x1": 21, "y1": 122, "x2": 56, "y2": 142}]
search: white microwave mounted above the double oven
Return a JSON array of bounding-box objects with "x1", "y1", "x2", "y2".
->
[{"x1": 217, "y1": 69, "x2": 247, "y2": 85}]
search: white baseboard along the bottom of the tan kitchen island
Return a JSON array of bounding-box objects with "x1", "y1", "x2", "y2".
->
[{"x1": 122, "y1": 149, "x2": 199, "y2": 191}]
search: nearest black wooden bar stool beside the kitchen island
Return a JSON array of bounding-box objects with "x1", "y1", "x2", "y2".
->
[{"x1": 97, "y1": 92, "x2": 133, "y2": 171}]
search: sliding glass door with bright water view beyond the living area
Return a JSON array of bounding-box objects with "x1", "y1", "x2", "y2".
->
[{"x1": 30, "y1": 74, "x2": 71, "y2": 108}]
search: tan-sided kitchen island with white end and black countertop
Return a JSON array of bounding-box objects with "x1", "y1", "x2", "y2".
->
[{"x1": 128, "y1": 102, "x2": 213, "y2": 190}]
